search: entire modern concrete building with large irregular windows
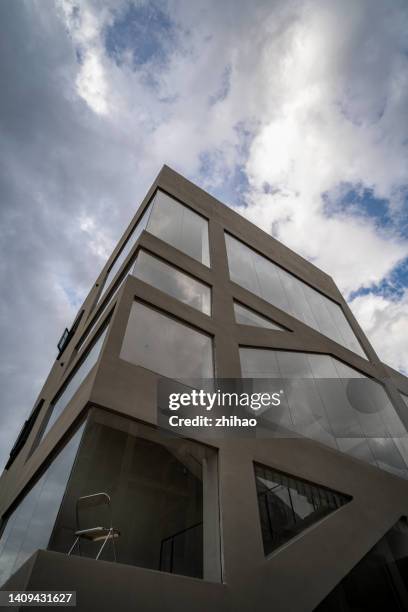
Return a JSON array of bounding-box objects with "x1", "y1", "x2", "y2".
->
[{"x1": 0, "y1": 166, "x2": 408, "y2": 612}]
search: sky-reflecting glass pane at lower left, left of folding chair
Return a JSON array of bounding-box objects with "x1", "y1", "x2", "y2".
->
[{"x1": 0, "y1": 426, "x2": 83, "y2": 586}]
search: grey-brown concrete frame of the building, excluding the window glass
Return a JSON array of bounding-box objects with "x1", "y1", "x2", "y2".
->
[{"x1": 0, "y1": 166, "x2": 408, "y2": 612}]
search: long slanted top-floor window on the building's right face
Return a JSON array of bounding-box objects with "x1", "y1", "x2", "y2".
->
[{"x1": 225, "y1": 234, "x2": 366, "y2": 358}]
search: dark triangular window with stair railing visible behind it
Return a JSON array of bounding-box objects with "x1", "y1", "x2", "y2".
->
[{"x1": 254, "y1": 464, "x2": 351, "y2": 555}]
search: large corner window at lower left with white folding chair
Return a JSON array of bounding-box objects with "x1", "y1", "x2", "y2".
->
[{"x1": 0, "y1": 409, "x2": 220, "y2": 585}]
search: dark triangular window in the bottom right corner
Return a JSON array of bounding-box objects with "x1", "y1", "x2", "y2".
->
[{"x1": 315, "y1": 518, "x2": 408, "y2": 612}]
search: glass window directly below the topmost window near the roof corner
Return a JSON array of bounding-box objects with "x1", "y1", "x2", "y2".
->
[{"x1": 132, "y1": 250, "x2": 211, "y2": 315}]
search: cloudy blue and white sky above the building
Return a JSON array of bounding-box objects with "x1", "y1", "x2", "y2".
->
[{"x1": 0, "y1": 0, "x2": 408, "y2": 464}]
